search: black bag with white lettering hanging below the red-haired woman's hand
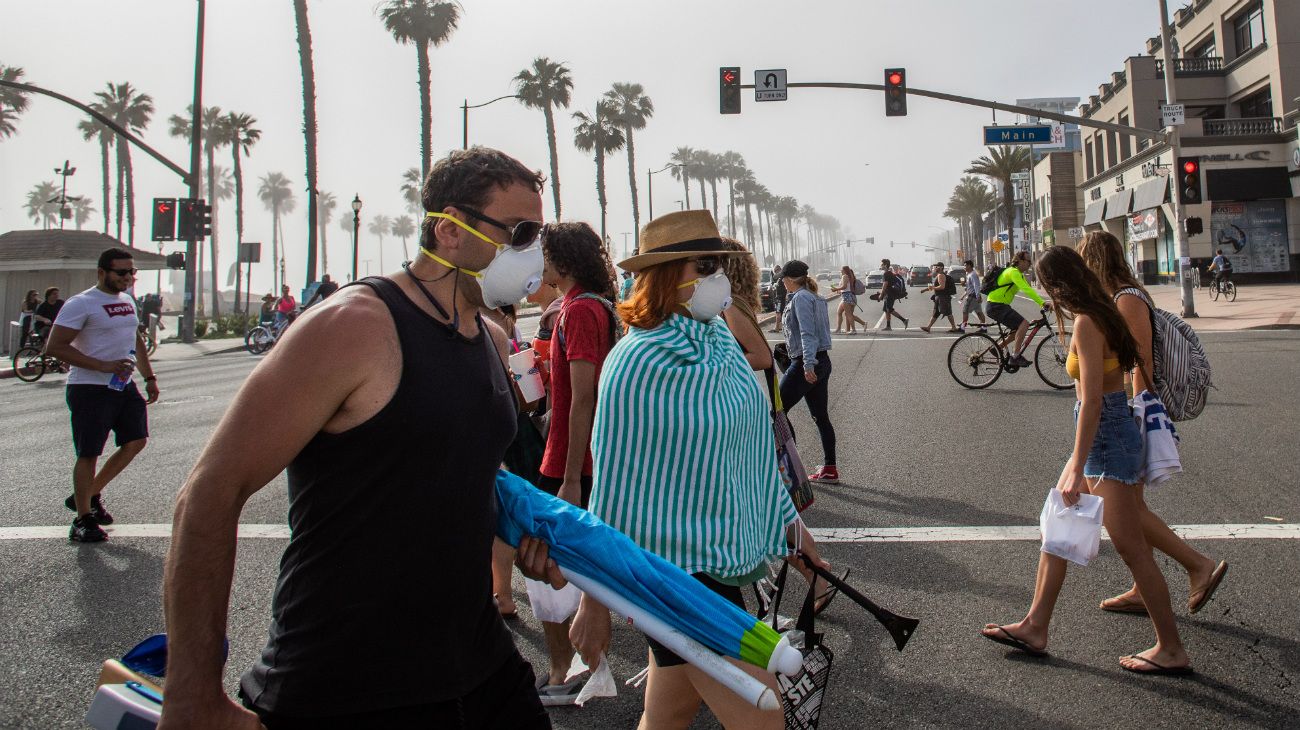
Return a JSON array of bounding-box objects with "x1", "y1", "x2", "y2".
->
[{"x1": 771, "y1": 564, "x2": 835, "y2": 730}]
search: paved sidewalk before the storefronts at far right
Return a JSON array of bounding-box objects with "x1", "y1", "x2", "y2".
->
[{"x1": 1148, "y1": 284, "x2": 1300, "y2": 331}]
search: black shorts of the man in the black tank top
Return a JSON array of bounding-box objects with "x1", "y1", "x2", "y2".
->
[{"x1": 239, "y1": 646, "x2": 551, "y2": 730}]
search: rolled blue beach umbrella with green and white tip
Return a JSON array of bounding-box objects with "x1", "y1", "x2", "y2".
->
[{"x1": 497, "y1": 472, "x2": 802, "y2": 674}]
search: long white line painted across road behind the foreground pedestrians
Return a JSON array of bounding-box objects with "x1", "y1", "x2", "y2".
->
[{"x1": 0, "y1": 523, "x2": 1300, "y2": 543}]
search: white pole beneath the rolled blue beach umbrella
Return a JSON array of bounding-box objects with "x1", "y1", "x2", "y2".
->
[{"x1": 560, "y1": 568, "x2": 781, "y2": 711}]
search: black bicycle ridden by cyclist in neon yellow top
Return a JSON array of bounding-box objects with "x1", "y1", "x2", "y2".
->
[{"x1": 948, "y1": 308, "x2": 1074, "y2": 390}]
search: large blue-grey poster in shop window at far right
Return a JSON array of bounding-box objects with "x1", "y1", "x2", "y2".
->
[{"x1": 1210, "y1": 200, "x2": 1291, "y2": 273}]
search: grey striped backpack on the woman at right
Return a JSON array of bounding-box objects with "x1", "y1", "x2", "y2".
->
[{"x1": 1115, "y1": 287, "x2": 1213, "y2": 421}]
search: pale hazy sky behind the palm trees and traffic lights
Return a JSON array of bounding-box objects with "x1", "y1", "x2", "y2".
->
[{"x1": 0, "y1": 0, "x2": 1158, "y2": 290}]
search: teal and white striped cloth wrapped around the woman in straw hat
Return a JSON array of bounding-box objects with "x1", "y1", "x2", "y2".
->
[{"x1": 590, "y1": 309, "x2": 798, "y2": 585}]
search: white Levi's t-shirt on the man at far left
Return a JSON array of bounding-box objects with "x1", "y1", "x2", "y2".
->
[{"x1": 55, "y1": 287, "x2": 140, "y2": 386}]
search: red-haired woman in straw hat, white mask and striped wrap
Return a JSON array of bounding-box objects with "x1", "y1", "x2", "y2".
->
[{"x1": 571, "y1": 210, "x2": 826, "y2": 729}]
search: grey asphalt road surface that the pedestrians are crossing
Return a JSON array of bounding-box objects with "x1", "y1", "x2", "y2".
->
[{"x1": 0, "y1": 292, "x2": 1300, "y2": 730}]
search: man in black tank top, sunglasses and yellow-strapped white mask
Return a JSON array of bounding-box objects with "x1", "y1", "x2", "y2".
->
[{"x1": 159, "y1": 147, "x2": 564, "y2": 730}]
